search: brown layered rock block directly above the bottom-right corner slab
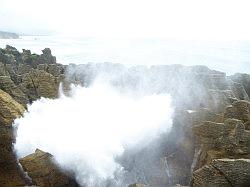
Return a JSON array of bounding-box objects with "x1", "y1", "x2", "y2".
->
[{"x1": 193, "y1": 119, "x2": 250, "y2": 169}]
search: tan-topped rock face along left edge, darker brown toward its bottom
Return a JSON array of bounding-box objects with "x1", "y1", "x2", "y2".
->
[{"x1": 0, "y1": 90, "x2": 25, "y2": 187}]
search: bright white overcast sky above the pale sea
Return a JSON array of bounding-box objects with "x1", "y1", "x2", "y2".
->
[{"x1": 0, "y1": 0, "x2": 250, "y2": 40}]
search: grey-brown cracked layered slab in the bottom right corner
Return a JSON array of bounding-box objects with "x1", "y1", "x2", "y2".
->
[{"x1": 192, "y1": 159, "x2": 250, "y2": 187}]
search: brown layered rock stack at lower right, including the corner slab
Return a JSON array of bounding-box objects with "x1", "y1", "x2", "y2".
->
[{"x1": 191, "y1": 97, "x2": 250, "y2": 187}]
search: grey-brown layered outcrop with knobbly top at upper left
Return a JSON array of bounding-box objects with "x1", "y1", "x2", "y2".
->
[{"x1": 0, "y1": 45, "x2": 63, "y2": 106}]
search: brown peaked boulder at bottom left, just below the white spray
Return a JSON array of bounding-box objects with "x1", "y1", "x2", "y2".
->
[{"x1": 19, "y1": 149, "x2": 78, "y2": 187}]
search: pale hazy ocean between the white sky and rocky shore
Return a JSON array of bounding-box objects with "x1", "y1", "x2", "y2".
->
[{"x1": 0, "y1": 36, "x2": 250, "y2": 74}]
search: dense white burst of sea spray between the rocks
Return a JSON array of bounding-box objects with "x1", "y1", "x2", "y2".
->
[{"x1": 14, "y1": 81, "x2": 173, "y2": 186}]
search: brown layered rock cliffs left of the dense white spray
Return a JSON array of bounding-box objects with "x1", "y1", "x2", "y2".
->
[{"x1": 0, "y1": 46, "x2": 78, "y2": 187}]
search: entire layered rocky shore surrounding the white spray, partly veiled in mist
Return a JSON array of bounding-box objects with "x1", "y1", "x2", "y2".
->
[{"x1": 0, "y1": 46, "x2": 250, "y2": 187}]
